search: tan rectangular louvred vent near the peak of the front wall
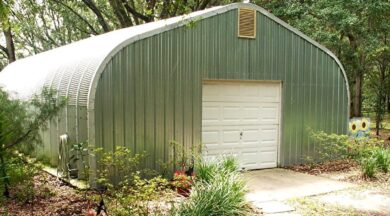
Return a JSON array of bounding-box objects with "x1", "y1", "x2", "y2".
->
[{"x1": 238, "y1": 8, "x2": 256, "y2": 38}]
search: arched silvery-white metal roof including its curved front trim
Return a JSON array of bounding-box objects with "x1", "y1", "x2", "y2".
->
[{"x1": 0, "y1": 3, "x2": 350, "y2": 109}]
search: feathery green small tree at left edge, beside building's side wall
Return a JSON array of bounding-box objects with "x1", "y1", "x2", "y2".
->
[{"x1": 0, "y1": 89, "x2": 66, "y2": 197}]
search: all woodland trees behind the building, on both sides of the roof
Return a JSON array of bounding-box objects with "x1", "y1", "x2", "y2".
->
[{"x1": 0, "y1": 0, "x2": 390, "y2": 126}]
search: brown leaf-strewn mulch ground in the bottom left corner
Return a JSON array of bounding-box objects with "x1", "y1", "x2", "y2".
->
[{"x1": 0, "y1": 172, "x2": 96, "y2": 216}]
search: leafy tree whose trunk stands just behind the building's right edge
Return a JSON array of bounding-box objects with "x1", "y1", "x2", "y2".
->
[{"x1": 255, "y1": 0, "x2": 390, "y2": 116}]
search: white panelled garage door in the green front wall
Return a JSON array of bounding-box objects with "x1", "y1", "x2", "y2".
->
[{"x1": 202, "y1": 82, "x2": 281, "y2": 169}]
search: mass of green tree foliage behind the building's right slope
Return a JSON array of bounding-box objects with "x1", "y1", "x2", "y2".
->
[{"x1": 254, "y1": 0, "x2": 390, "y2": 119}]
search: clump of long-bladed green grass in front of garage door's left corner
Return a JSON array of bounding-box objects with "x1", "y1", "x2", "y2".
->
[{"x1": 171, "y1": 158, "x2": 249, "y2": 216}]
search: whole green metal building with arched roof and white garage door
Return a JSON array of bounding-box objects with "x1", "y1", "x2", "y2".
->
[{"x1": 0, "y1": 3, "x2": 349, "y2": 180}]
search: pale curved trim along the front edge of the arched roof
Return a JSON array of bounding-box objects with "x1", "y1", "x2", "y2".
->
[{"x1": 87, "y1": 3, "x2": 350, "y2": 116}]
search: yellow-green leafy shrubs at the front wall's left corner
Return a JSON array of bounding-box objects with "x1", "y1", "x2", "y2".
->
[{"x1": 96, "y1": 146, "x2": 169, "y2": 215}]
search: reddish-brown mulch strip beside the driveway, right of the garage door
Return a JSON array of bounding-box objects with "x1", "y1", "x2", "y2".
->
[{"x1": 287, "y1": 159, "x2": 358, "y2": 175}]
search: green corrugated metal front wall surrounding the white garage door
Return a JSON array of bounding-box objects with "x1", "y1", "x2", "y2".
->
[{"x1": 95, "y1": 10, "x2": 348, "y2": 169}]
